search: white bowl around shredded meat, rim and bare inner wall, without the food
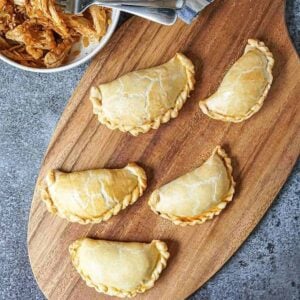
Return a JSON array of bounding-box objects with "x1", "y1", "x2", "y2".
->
[{"x1": 0, "y1": 9, "x2": 120, "y2": 73}]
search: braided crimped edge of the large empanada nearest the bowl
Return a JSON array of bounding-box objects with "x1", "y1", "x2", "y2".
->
[{"x1": 90, "y1": 53, "x2": 195, "y2": 136}]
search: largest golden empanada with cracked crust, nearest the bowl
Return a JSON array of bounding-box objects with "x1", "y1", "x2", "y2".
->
[{"x1": 90, "y1": 53, "x2": 195, "y2": 136}]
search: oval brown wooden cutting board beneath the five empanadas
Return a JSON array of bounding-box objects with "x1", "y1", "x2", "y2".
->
[{"x1": 28, "y1": 0, "x2": 300, "y2": 300}]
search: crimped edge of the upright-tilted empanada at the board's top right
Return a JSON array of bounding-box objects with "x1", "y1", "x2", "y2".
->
[{"x1": 199, "y1": 39, "x2": 275, "y2": 123}]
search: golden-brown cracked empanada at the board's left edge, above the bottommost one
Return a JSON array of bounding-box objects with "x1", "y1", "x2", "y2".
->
[{"x1": 41, "y1": 163, "x2": 147, "y2": 224}]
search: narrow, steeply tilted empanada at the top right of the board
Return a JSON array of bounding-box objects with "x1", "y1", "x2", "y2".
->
[{"x1": 199, "y1": 39, "x2": 274, "y2": 123}]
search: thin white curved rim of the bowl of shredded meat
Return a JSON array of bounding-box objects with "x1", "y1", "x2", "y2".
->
[{"x1": 0, "y1": 8, "x2": 120, "y2": 73}]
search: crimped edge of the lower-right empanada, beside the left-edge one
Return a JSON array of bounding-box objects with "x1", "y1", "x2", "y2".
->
[{"x1": 148, "y1": 146, "x2": 235, "y2": 226}]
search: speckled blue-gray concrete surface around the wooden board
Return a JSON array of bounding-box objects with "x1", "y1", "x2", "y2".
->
[{"x1": 0, "y1": 0, "x2": 300, "y2": 300}]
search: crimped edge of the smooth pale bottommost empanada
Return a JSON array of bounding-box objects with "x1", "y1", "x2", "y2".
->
[{"x1": 69, "y1": 238, "x2": 170, "y2": 298}]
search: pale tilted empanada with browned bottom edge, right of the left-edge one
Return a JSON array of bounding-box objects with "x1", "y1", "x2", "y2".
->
[{"x1": 149, "y1": 146, "x2": 235, "y2": 226}]
